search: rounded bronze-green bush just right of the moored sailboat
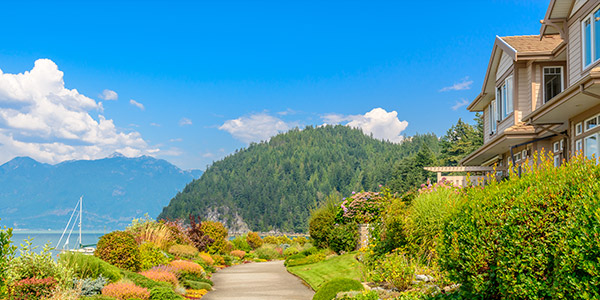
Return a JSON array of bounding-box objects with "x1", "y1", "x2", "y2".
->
[{"x1": 94, "y1": 231, "x2": 140, "y2": 272}]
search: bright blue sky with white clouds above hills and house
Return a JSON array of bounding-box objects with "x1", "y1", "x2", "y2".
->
[{"x1": 0, "y1": 0, "x2": 548, "y2": 169}]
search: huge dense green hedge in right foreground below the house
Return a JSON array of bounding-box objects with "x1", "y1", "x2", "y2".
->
[{"x1": 438, "y1": 155, "x2": 600, "y2": 299}]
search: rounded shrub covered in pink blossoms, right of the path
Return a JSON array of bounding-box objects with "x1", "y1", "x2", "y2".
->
[{"x1": 340, "y1": 192, "x2": 385, "y2": 223}]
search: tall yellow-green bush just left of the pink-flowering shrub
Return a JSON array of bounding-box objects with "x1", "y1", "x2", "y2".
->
[{"x1": 308, "y1": 194, "x2": 341, "y2": 248}]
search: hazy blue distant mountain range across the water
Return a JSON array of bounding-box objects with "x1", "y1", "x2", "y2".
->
[{"x1": 0, "y1": 153, "x2": 202, "y2": 230}]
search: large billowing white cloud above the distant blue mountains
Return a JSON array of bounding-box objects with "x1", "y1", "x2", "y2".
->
[{"x1": 0, "y1": 59, "x2": 156, "y2": 163}]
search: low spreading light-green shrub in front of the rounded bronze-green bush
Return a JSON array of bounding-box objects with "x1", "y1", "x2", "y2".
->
[{"x1": 58, "y1": 252, "x2": 121, "y2": 282}]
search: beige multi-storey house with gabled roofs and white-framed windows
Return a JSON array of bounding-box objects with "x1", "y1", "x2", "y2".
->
[{"x1": 428, "y1": 0, "x2": 600, "y2": 184}]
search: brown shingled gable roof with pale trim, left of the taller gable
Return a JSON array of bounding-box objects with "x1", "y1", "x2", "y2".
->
[{"x1": 467, "y1": 34, "x2": 564, "y2": 111}]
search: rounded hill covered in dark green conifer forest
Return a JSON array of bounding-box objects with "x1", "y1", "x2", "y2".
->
[{"x1": 159, "y1": 125, "x2": 440, "y2": 232}]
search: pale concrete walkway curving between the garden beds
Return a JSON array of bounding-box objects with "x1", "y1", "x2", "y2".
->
[{"x1": 202, "y1": 261, "x2": 315, "y2": 300}]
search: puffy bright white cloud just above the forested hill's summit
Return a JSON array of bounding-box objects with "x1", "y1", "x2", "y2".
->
[{"x1": 321, "y1": 108, "x2": 408, "y2": 143}]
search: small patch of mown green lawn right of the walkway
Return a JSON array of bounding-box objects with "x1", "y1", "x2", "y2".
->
[{"x1": 287, "y1": 253, "x2": 362, "y2": 291}]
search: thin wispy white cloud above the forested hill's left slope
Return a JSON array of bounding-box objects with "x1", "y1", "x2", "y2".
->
[{"x1": 219, "y1": 113, "x2": 290, "y2": 143}]
